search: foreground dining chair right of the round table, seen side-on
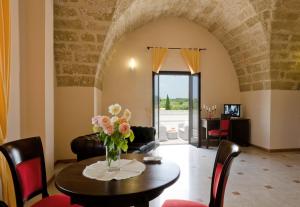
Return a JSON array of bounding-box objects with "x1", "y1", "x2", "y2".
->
[{"x1": 162, "y1": 140, "x2": 240, "y2": 207}]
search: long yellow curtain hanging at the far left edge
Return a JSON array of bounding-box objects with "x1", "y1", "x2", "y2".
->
[{"x1": 0, "y1": 0, "x2": 16, "y2": 207}]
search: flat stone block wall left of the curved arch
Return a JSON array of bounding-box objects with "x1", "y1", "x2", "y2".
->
[{"x1": 54, "y1": 0, "x2": 116, "y2": 87}]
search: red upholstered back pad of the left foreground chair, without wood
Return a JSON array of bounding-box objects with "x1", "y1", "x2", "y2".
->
[{"x1": 16, "y1": 158, "x2": 42, "y2": 200}]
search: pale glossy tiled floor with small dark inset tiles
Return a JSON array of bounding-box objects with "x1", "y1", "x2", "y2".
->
[{"x1": 27, "y1": 145, "x2": 300, "y2": 207}]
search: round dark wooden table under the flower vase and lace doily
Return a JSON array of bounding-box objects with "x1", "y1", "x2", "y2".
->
[{"x1": 55, "y1": 154, "x2": 180, "y2": 207}]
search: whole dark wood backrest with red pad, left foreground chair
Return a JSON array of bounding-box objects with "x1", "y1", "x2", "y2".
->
[{"x1": 0, "y1": 137, "x2": 48, "y2": 207}]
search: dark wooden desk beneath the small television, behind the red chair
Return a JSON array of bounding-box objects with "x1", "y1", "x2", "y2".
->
[{"x1": 201, "y1": 118, "x2": 250, "y2": 146}]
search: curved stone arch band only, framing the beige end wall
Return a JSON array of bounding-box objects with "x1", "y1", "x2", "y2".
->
[{"x1": 95, "y1": 0, "x2": 270, "y2": 91}]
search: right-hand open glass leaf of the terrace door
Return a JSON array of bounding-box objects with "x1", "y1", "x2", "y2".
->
[{"x1": 189, "y1": 73, "x2": 201, "y2": 147}]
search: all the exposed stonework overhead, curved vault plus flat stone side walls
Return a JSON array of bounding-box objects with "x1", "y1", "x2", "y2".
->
[{"x1": 54, "y1": 0, "x2": 300, "y2": 91}]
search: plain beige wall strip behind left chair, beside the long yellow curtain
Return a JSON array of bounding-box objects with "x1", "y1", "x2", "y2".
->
[{"x1": 20, "y1": 0, "x2": 45, "y2": 141}]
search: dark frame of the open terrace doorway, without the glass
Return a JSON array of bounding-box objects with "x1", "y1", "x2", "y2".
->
[{"x1": 152, "y1": 71, "x2": 201, "y2": 147}]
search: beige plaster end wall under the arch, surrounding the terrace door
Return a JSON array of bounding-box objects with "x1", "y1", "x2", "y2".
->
[{"x1": 102, "y1": 17, "x2": 240, "y2": 126}]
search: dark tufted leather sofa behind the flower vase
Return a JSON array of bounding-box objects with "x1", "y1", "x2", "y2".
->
[{"x1": 71, "y1": 126, "x2": 158, "y2": 161}]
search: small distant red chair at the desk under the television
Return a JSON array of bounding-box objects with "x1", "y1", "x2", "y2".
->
[{"x1": 206, "y1": 119, "x2": 230, "y2": 148}]
